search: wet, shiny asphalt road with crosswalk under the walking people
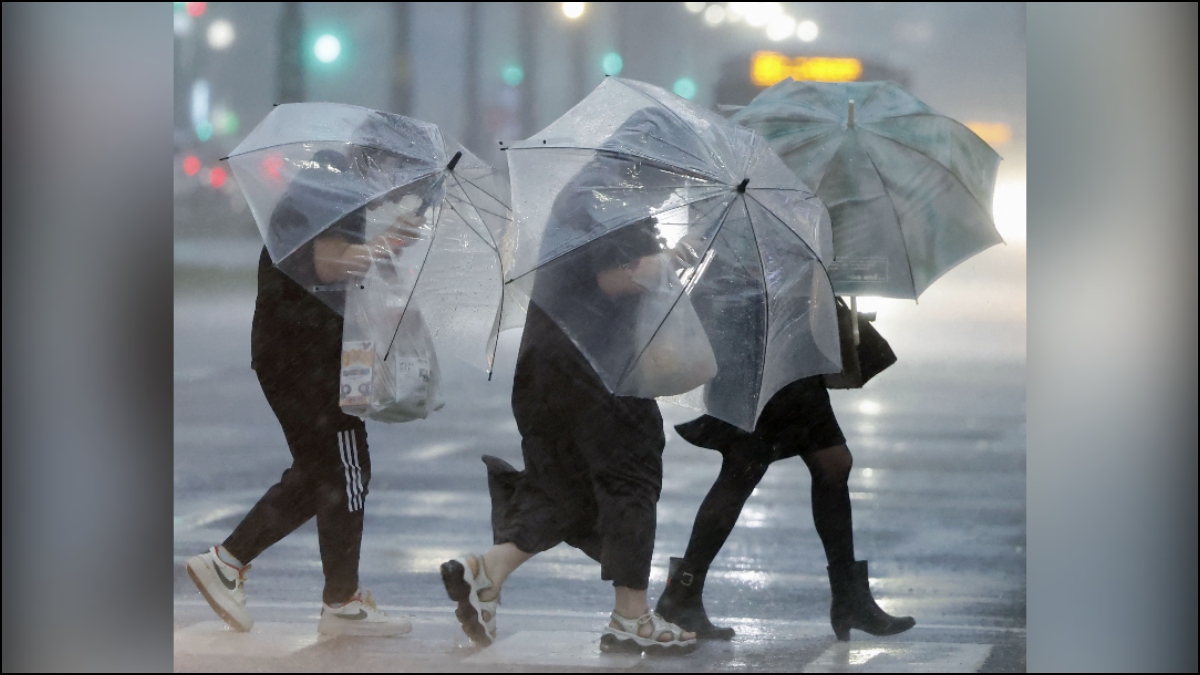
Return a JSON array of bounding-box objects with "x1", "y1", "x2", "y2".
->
[{"x1": 173, "y1": 236, "x2": 1026, "y2": 671}]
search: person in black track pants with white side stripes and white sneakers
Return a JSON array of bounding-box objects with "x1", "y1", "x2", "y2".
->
[{"x1": 186, "y1": 150, "x2": 420, "y2": 635}]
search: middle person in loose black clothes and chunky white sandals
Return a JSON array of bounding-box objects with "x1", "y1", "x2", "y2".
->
[{"x1": 440, "y1": 110, "x2": 696, "y2": 651}]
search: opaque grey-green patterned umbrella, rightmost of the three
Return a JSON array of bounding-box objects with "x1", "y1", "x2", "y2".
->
[{"x1": 730, "y1": 79, "x2": 1002, "y2": 299}]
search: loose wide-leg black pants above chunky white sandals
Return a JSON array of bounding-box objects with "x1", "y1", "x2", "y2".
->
[{"x1": 494, "y1": 305, "x2": 666, "y2": 590}]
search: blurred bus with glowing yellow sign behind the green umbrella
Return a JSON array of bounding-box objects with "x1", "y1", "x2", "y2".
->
[{"x1": 716, "y1": 52, "x2": 911, "y2": 106}]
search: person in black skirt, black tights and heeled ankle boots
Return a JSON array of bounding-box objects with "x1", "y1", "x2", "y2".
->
[{"x1": 655, "y1": 301, "x2": 916, "y2": 640}]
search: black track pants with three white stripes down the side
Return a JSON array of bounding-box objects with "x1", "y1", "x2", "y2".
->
[{"x1": 222, "y1": 360, "x2": 371, "y2": 603}]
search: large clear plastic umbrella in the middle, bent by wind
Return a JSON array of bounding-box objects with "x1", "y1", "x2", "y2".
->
[{"x1": 508, "y1": 78, "x2": 841, "y2": 429}]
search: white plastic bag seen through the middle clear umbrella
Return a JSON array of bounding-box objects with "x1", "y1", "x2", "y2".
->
[{"x1": 628, "y1": 253, "x2": 716, "y2": 399}]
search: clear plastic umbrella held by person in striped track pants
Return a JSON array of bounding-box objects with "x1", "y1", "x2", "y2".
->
[{"x1": 228, "y1": 103, "x2": 511, "y2": 374}]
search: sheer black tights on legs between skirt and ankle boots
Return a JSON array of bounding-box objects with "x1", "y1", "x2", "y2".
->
[{"x1": 685, "y1": 441, "x2": 854, "y2": 569}]
